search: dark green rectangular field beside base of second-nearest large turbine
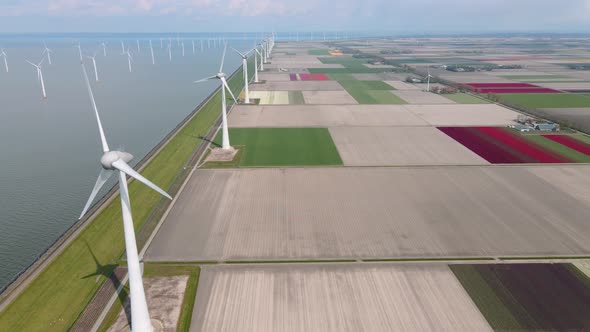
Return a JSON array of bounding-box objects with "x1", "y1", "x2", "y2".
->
[{"x1": 214, "y1": 128, "x2": 342, "y2": 167}]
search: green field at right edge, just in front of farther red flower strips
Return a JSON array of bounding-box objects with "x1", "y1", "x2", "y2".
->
[{"x1": 498, "y1": 93, "x2": 590, "y2": 109}]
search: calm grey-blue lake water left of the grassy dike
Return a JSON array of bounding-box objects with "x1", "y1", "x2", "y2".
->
[{"x1": 0, "y1": 34, "x2": 254, "y2": 288}]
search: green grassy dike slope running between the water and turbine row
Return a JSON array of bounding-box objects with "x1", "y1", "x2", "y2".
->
[{"x1": 0, "y1": 58, "x2": 253, "y2": 331}]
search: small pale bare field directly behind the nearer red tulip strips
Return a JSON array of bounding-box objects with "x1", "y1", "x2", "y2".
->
[{"x1": 404, "y1": 104, "x2": 518, "y2": 126}]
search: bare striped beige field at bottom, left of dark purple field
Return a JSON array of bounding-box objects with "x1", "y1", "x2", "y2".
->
[{"x1": 191, "y1": 264, "x2": 491, "y2": 332}]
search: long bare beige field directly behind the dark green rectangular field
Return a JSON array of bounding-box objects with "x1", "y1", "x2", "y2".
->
[{"x1": 229, "y1": 105, "x2": 428, "y2": 128}]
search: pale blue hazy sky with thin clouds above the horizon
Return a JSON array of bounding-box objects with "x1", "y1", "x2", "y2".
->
[{"x1": 0, "y1": 0, "x2": 590, "y2": 34}]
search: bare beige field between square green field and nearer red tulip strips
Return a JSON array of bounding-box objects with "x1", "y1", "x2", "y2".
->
[{"x1": 330, "y1": 127, "x2": 488, "y2": 166}]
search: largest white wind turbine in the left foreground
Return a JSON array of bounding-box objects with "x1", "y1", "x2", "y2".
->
[{"x1": 80, "y1": 59, "x2": 172, "y2": 331}]
